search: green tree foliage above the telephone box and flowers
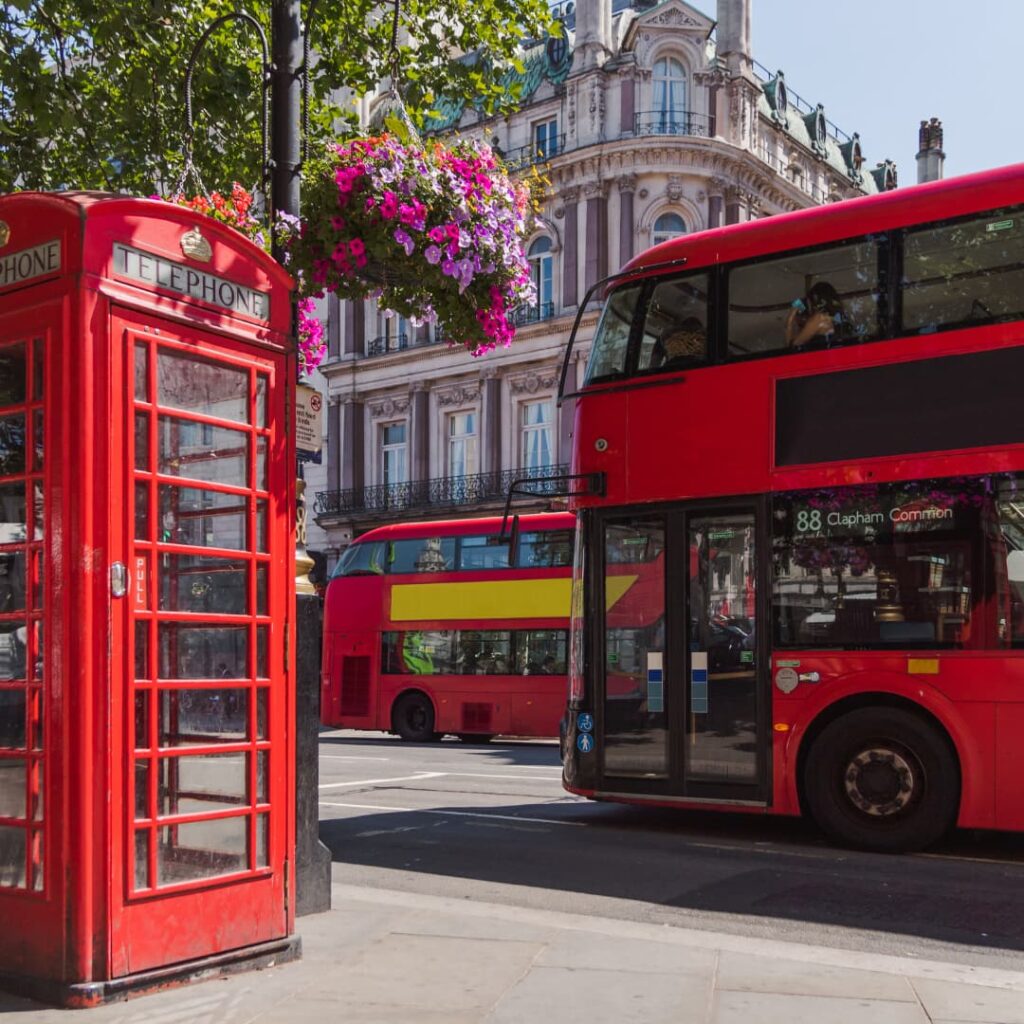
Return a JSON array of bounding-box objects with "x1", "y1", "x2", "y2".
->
[{"x1": 0, "y1": 0, "x2": 550, "y2": 195}]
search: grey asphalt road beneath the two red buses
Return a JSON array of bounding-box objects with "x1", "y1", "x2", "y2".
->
[{"x1": 319, "y1": 731, "x2": 1024, "y2": 970}]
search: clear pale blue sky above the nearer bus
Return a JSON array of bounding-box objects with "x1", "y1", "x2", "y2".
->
[{"x1": 691, "y1": 0, "x2": 1024, "y2": 184}]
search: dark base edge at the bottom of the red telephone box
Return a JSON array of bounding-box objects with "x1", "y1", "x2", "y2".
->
[{"x1": 0, "y1": 935, "x2": 302, "y2": 1009}]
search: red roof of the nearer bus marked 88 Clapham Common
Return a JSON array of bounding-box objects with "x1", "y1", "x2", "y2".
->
[{"x1": 616, "y1": 164, "x2": 1024, "y2": 287}]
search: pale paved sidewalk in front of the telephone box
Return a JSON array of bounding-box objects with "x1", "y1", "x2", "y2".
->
[{"x1": 0, "y1": 883, "x2": 1024, "y2": 1024}]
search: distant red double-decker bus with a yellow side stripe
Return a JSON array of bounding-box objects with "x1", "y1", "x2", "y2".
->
[{"x1": 321, "y1": 512, "x2": 574, "y2": 742}]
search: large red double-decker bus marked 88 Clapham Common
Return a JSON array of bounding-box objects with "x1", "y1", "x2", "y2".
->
[{"x1": 562, "y1": 165, "x2": 1024, "y2": 850}]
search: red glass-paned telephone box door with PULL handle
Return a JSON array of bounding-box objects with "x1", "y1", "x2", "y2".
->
[{"x1": 111, "y1": 311, "x2": 292, "y2": 976}]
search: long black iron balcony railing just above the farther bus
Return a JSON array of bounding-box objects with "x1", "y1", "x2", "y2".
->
[{"x1": 313, "y1": 465, "x2": 569, "y2": 515}]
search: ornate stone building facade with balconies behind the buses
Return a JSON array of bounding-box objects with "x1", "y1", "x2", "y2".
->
[{"x1": 307, "y1": 0, "x2": 896, "y2": 565}]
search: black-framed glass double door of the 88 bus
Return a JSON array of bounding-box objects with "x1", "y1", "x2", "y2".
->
[{"x1": 595, "y1": 503, "x2": 770, "y2": 802}]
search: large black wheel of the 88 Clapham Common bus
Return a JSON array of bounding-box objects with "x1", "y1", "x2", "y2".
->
[{"x1": 804, "y1": 708, "x2": 961, "y2": 853}]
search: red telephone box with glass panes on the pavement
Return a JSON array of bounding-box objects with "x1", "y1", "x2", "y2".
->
[{"x1": 0, "y1": 193, "x2": 298, "y2": 1006}]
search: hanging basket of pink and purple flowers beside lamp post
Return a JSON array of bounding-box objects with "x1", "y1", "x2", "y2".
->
[{"x1": 278, "y1": 134, "x2": 534, "y2": 355}]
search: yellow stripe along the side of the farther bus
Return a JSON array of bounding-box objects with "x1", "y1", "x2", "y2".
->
[{"x1": 391, "y1": 577, "x2": 572, "y2": 623}]
